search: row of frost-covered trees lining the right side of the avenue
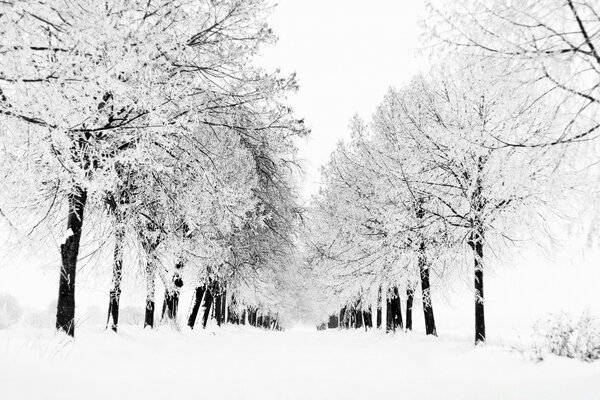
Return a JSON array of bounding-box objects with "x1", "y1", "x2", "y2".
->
[{"x1": 308, "y1": 0, "x2": 600, "y2": 343}]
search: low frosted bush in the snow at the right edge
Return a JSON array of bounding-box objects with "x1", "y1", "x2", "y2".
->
[{"x1": 533, "y1": 312, "x2": 600, "y2": 362}]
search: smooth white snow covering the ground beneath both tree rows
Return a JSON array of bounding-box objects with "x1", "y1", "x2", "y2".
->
[{"x1": 0, "y1": 326, "x2": 600, "y2": 400}]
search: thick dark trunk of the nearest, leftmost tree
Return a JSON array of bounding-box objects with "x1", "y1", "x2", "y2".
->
[{"x1": 56, "y1": 187, "x2": 87, "y2": 337}]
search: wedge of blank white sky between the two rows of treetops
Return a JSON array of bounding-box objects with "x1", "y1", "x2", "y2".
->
[{"x1": 263, "y1": 0, "x2": 425, "y2": 197}]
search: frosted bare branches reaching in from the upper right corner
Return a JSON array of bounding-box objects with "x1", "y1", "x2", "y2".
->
[{"x1": 425, "y1": 0, "x2": 600, "y2": 146}]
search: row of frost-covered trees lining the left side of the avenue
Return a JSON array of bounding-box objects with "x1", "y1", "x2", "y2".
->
[{"x1": 0, "y1": 0, "x2": 307, "y2": 336}]
